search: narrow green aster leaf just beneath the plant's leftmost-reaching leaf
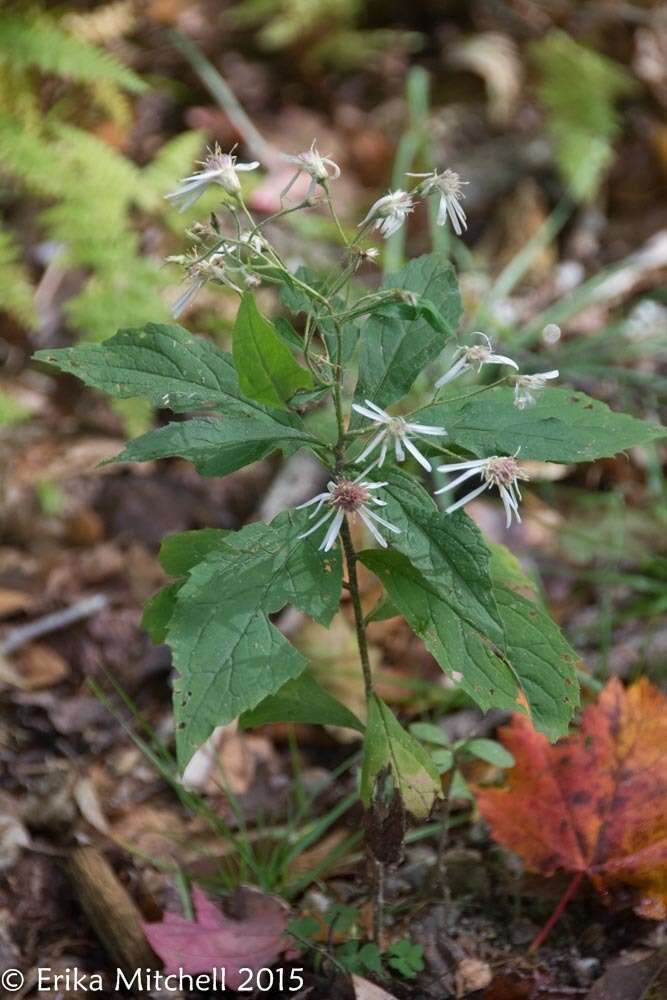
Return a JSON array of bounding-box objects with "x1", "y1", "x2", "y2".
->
[{"x1": 111, "y1": 416, "x2": 314, "y2": 476}]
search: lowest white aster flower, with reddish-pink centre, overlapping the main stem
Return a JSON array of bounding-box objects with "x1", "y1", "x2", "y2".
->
[{"x1": 297, "y1": 466, "x2": 401, "y2": 552}]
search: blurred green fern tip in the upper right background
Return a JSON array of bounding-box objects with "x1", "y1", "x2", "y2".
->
[{"x1": 531, "y1": 31, "x2": 636, "y2": 201}]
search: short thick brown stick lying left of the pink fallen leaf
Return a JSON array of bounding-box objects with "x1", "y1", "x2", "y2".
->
[{"x1": 68, "y1": 847, "x2": 160, "y2": 978}]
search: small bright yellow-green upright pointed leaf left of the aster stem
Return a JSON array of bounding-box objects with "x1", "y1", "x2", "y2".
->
[{"x1": 233, "y1": 292, "x2": 314, "y2": 407}]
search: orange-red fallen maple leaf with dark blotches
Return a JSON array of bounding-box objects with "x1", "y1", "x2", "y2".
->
[{"x1": 476, "y1": 679, "x2": 667, "y2": 920}]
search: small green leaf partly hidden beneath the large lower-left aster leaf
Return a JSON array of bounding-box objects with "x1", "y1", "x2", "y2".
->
[{"x1": 239, "y1": 670, "x2": 364, "y2": 733}]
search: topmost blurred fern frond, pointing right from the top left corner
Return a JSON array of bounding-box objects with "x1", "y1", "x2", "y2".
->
[{"x1": 0, "y1": 12, "x2": 146, "y2": 94}]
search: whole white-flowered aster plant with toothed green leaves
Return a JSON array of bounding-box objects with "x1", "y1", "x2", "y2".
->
[{"x1": 37, "y1": 144, "x2": 663, "y2": 908}]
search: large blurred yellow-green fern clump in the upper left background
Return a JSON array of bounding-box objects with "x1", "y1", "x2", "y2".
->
[{"x1": 0, "y1": 8, "x2": 203, "y2": 340}]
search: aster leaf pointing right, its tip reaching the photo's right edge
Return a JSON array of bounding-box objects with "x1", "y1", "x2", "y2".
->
[{"x1": 410, "y1": 386, "x2": 667, "y2": 462}]
